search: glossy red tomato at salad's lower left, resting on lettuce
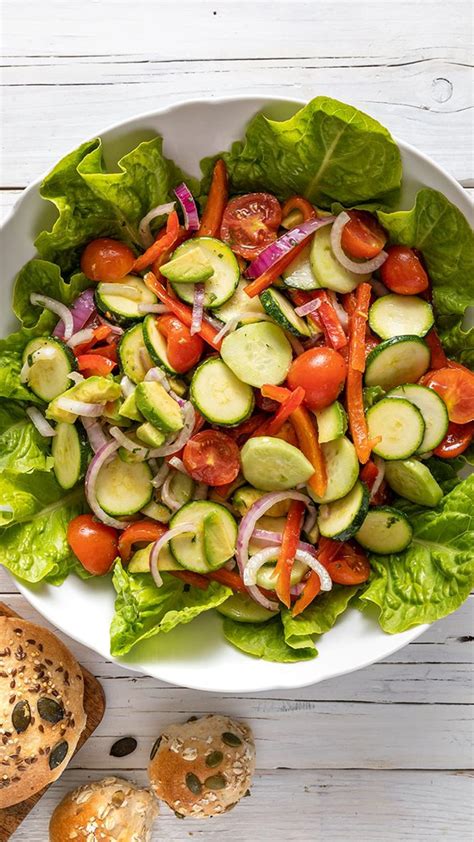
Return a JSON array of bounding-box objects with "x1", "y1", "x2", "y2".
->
[{"x1": 67, "y1": 515, "x2": 118, "y2": 576}]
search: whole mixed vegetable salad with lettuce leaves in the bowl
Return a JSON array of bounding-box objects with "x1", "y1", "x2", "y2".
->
[{"x1": 0, "y1": 97, "x2": 474, "y2": 662}]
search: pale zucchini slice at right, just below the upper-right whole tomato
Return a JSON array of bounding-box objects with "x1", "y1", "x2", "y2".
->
[{"x1": 369, "y1": 295, "x2": 434, "y2": 339}]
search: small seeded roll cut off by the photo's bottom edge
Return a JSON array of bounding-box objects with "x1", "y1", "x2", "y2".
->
[{"x1": 49, "y1": 778, "x2": 158, "y2": 842}]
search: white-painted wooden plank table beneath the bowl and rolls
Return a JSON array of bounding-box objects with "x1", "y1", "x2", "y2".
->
[{"x1": 0, "y1": 0, "x2": 474, "y2": 842}]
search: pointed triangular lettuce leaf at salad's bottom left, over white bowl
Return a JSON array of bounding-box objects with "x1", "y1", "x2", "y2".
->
[{"x1": 110, "y1": 560, "x2": 232, "y2": 655}]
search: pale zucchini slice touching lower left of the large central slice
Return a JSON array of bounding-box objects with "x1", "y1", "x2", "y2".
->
[{"x1": 189, "y1": 357, "x2": 254, "y2": 426}]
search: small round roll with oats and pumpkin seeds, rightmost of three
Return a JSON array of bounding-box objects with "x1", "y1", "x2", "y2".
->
[{"x1": 148, "y1": 714, "x2": 255, "y2": 819}]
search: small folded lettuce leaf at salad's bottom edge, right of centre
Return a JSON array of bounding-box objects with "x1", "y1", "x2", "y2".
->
[{"x1": 281, "y1": 585, "x2": 358, "y2": 649}]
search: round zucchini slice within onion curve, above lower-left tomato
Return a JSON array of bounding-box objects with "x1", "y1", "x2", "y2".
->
[{"x1": 96, "y1": 456, "x2": 153, "y2": 517}]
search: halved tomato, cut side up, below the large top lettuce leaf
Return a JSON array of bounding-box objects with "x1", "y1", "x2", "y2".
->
[{"x1": 221, "y1": 193, "x2": 281, "y2": 260}]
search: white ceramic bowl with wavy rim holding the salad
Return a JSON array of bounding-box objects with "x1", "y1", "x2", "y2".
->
[{"x1": 0, "y1": 97, "x2": 470, "y2": 693}]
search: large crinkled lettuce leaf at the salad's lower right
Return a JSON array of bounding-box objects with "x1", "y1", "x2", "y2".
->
[{"x1": 361, "y1": 474, "x2": 474, "y2": 634}]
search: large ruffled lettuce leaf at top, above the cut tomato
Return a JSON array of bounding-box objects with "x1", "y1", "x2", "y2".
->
[{"x1": 202, "y1": 97, "x2": 402, "y2": 208}]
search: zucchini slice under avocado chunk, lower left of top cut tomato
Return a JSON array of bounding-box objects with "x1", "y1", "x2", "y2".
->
[{"x1": 172, "y1": 237, "x2": 240, "y2": 308}]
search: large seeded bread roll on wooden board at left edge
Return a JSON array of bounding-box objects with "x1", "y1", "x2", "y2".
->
[{"x1": 0, "y1": 617, "x2": 86, "y2": 808}]
